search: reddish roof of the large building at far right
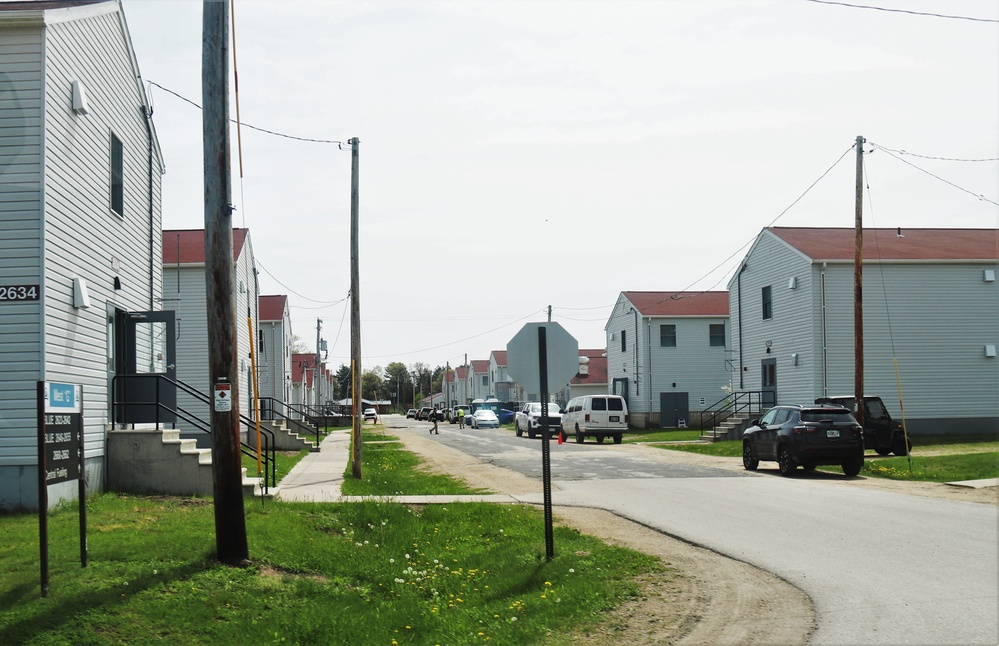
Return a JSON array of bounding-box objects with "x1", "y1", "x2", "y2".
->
[{"x1": 767, "y1": 227, "x2": 999, "y2": 261}]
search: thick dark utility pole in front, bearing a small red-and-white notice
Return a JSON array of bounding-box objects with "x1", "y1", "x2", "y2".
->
[{"x1": 201, "y1": 0, "x2": 249, "y2": 565}]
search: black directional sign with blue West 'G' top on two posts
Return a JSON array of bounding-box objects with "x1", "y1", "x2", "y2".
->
[{"x1": 38, "y1": 381, "x2": 87, "y2": 597}]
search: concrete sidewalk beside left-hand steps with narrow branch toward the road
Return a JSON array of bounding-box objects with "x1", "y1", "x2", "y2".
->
[{"x1": 274, "y1": 430, "x2": 542, "y2": 505}]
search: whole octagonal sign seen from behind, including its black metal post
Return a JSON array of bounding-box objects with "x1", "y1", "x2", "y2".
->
[{"x1": 506, "y1": 323, "x2": 579, "y2": 561}]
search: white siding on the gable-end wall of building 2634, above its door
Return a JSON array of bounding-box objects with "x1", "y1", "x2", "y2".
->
[{"x1": 45, "y1": 7, "x2": 162, "y2": 468}]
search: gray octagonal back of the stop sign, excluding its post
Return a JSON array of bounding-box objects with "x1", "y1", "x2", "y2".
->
[{"x1": 506, "y1": 323, "x2": 579, "y2": 393}]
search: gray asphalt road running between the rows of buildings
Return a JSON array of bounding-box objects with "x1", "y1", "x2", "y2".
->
[{"x1": 394, "y1": 422, "x2": 999, "y2": 645}]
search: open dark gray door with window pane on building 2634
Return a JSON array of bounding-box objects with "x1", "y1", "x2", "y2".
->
[{"x1": 115, "y1": 310, "x2": 177, "y2": 424}]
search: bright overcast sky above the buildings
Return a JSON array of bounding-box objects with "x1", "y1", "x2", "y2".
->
[{"x1": 124, "y1": 0, "x2": 999, "y2": 369}]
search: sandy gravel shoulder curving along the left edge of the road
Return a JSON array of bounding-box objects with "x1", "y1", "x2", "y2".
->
[{"x1": 391, "y1": 425, "x2": 815, "y2": 645}]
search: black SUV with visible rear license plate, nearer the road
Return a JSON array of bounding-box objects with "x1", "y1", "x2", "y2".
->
[{"x1": 742, "y1": 404, "x2": 864, "y2": 477}]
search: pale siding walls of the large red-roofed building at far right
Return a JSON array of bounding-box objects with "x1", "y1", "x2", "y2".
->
[{"x1": 729, "y1": 231, "x2": 999, "y2": 433}]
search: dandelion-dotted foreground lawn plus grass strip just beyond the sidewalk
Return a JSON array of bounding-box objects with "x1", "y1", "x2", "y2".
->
[{"x1": 0, "y1": 431, "x2": 677, "y2": 646}]
